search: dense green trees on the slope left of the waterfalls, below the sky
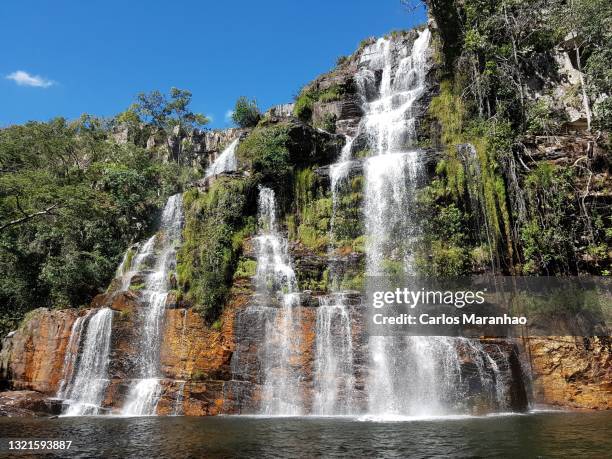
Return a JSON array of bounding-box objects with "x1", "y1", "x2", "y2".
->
[{"x1": 0, "y1": 115, "x2": 192, "y2": 334}]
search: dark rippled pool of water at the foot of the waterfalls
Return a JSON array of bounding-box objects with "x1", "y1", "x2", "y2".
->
[{"x1": 0, "y1": 412, "x2": 612, "y2": 458}]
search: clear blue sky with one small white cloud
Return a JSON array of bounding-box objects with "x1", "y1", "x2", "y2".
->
[{"x1": 0, "y1": 0, "x2": 425, "y2": 128}]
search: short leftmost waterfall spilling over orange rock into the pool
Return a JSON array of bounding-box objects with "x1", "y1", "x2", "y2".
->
[{"x1": 58, "y1": 308, "x2": 113, "y2": 416}]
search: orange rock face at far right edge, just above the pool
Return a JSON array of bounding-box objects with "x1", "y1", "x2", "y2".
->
[{"x1": 527, "y1": 336, "x2": 612, "y2": 409}]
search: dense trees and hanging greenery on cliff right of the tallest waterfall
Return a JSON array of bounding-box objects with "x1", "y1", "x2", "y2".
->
[{"x1": 424, "y1": 0, "x2": 612, "y2": 275}]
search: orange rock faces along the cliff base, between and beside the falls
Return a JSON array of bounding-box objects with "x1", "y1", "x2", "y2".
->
[{"x1": 0, "y1": 294, "x2": 612, "y2": 416}]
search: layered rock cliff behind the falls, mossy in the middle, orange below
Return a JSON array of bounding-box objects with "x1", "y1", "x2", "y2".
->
[{"x1": 0, "y1": 21, "x2": 612, "y2": 416}]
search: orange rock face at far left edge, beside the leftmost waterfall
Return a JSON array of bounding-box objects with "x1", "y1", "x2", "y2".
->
[{"x1": 0, "y1": 308, "x2": 79, "y2": 395}]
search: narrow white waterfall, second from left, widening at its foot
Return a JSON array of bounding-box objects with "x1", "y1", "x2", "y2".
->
[{"x1": 122, "y1": 194, "x2": 183, "y2": 416}]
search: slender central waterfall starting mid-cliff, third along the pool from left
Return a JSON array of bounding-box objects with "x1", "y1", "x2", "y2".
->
[{"x1": 252, "y1": 187, "x2": 304, "y2": 415}]
